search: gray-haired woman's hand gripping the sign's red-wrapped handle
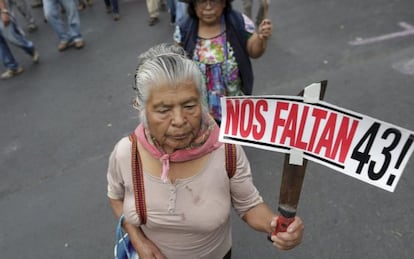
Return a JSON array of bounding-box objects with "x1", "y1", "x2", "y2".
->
[{"x1": 270, "y1": 217, "x2": 304, "y2": 250}]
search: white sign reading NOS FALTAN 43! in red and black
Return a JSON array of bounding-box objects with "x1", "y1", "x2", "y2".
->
[{"x1": 220, "y1": 96, "x2": 414, "y2": 192}]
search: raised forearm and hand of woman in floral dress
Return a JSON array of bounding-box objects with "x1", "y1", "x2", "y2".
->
[{"x1": 247, "y1": 19, "x2": 272, "y2": 58}]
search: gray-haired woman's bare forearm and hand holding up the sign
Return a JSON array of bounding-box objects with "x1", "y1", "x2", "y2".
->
[{"x1": 243, "y1": 203, "x2": 304, "y2": 250}]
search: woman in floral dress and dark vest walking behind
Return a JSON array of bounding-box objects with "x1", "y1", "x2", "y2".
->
[{"x1": 174, "y1": 0, "x2": 272, "y2": 122}]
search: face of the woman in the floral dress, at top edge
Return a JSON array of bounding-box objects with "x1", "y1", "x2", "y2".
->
[{"x1": 195, "y1": 0, "x2": 226, "y2": 25}]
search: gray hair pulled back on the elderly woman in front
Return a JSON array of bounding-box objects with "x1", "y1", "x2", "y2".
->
[{"x1": 133, "y1": 43, "x2": 208, "y2": 126}]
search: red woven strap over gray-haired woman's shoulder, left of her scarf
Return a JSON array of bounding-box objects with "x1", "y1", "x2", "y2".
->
[{"x1": 129, "y1": 132, "x2": 147, "y2": 225}]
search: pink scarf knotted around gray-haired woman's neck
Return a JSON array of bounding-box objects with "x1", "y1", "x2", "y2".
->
[{"x1": 135, "y1": 116, "x2": 223, "y2": 183}]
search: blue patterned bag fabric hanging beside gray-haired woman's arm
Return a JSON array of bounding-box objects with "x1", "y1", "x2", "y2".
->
[{"x1": 114, "y1": 215, "x2": 139, "y2": 259}]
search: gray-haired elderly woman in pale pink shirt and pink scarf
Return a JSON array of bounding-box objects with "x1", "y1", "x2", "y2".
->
[{"x1": 107, "y1": 44, "x2": 303, "y2": 259}]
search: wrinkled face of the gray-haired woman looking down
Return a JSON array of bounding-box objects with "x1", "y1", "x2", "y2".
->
[{"x1": 146, "y1": 81, "x2": 202, "y2": 153}]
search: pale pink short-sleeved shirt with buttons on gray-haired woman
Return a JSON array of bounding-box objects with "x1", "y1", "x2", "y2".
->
[{"x1": 107, "y1": 138, "x2": 263, "y2": 259}]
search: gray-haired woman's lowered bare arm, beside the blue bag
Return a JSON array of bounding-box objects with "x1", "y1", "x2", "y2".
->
[{"x1": 109, "y1": 198, "x2": 165, "y2": 259}]
